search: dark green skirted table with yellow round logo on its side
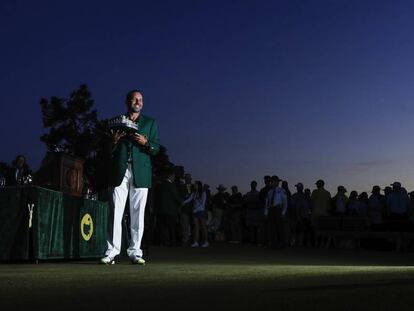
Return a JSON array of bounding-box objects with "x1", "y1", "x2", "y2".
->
[{"x1": 0, "y1": 187, "x2": 108, "y2": 260}]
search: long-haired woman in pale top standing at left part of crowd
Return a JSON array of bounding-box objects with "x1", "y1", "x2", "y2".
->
[{"x1": 183, "y1": 181, "x2": 208, "y2": 247}]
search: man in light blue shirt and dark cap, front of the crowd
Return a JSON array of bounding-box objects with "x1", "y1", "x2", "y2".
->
[{"x1": 265, "y1": 176, "x2": 288, "y2": 248}]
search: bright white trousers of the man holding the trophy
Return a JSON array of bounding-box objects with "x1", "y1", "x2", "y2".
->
[{"x1": 105, "y1": 164, "x2": 148, "y2": 258}]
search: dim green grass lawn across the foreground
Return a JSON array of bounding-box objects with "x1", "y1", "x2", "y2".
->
[{"x1": 0, "y1": 244, "x2": 414, "y2": 311}]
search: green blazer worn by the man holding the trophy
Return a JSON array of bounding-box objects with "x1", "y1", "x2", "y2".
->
[{"x1": 109, "y1": 115, "x2": 160, "y2": 188}]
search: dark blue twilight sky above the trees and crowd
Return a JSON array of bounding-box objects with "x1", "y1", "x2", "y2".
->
[{"x1": 0, "y1": 0, "x2": 414, "y2": 195}]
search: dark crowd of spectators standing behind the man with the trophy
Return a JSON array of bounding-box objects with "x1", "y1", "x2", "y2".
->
[{"x1": 153, "y1": 170, "x2": 414, "y2": 248}]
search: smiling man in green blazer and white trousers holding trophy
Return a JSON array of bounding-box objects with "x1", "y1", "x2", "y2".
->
[{"x1": 101, "y1": 90, "x2": 160, "y2": 265}]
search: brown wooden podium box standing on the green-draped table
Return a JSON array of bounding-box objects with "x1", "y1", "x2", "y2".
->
[{"x1": 35, "y1": 152, "x2": 85, "y2": 197}]
